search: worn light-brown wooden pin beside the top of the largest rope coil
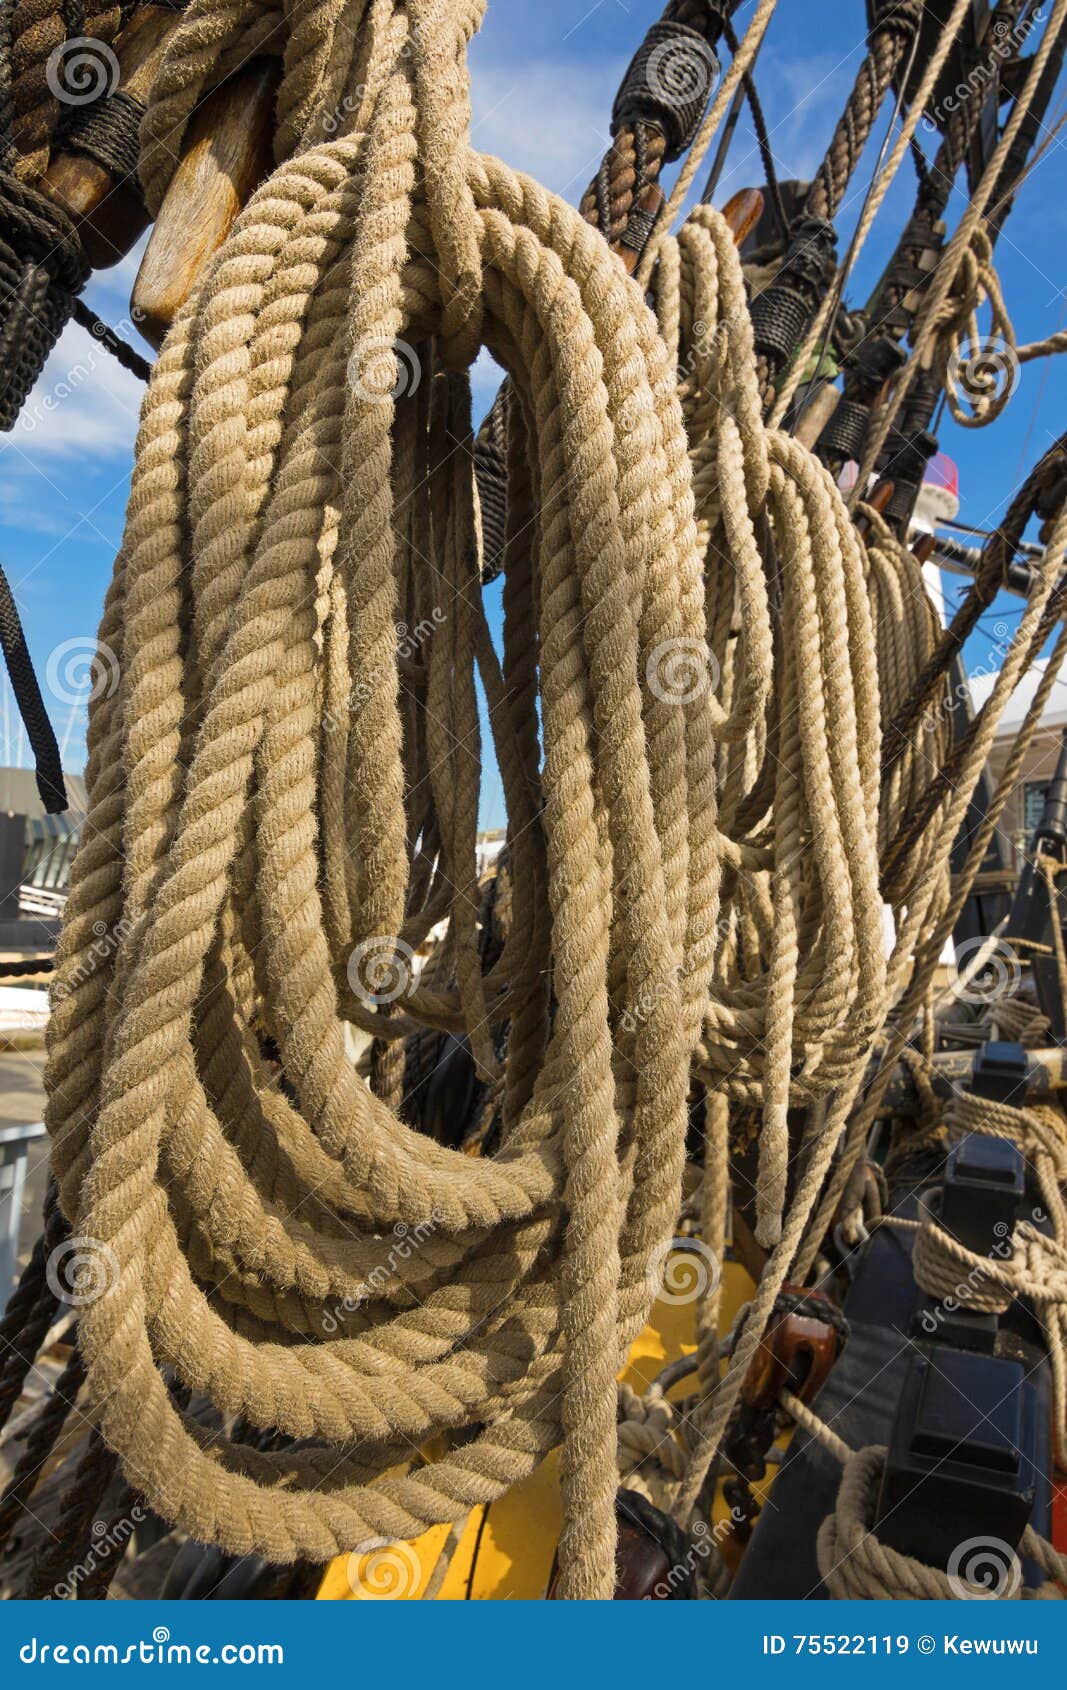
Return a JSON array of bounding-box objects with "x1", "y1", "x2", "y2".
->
[{"x1": 132, "y1": 57, "x2": 281, "y2": 346}]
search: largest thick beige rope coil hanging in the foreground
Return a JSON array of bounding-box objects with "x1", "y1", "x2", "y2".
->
[{"x1": 47, "y1": 0, "x2": 719, "y2": 1597}]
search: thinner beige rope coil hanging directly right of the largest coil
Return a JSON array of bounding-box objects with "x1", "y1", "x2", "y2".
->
[{"x1": 642, "y1": 206, "x2": 884, "y2": 1246}]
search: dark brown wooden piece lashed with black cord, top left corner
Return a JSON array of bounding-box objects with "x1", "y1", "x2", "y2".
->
[{"x1": 39, "y1": 5, "x2": 181, "y2": 270}]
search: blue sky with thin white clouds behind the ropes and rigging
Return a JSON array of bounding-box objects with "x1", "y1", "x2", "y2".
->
[{"x1": 0, "y1": 0, "x2": 1067, "y2": 826}]
